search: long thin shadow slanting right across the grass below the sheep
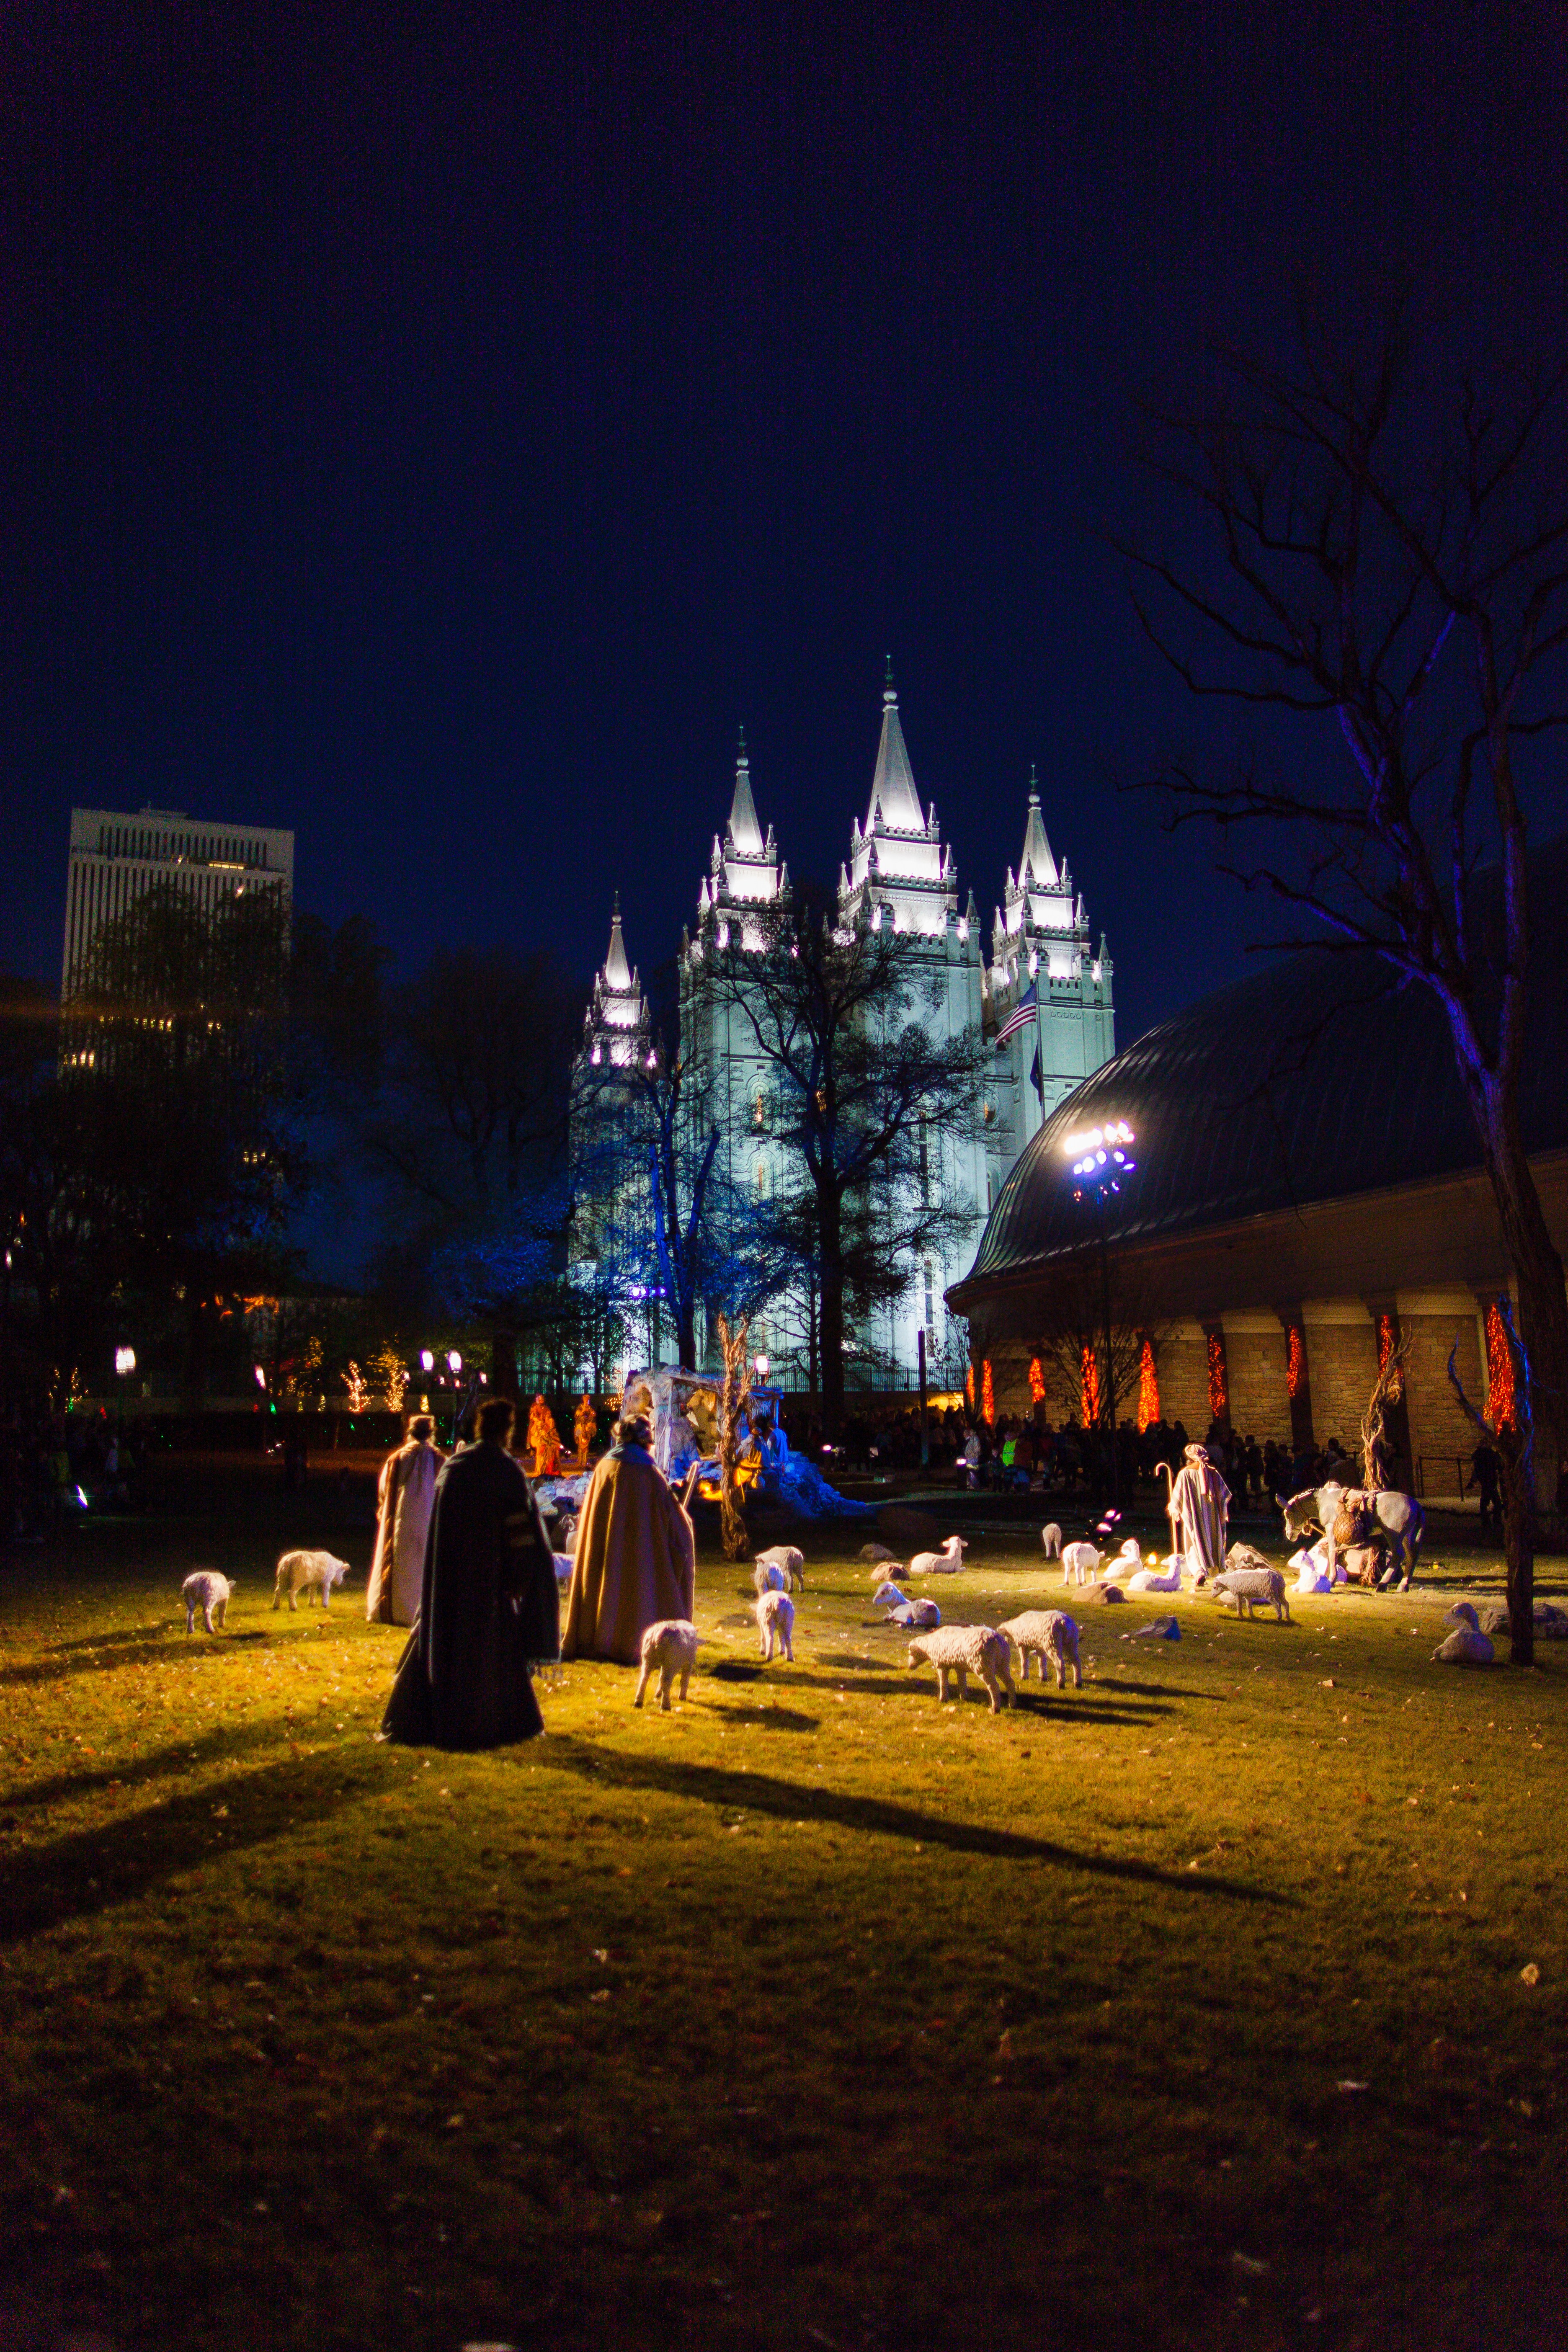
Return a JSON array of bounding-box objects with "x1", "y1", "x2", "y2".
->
[{"x1": 536, "y1": 1733, "x2": 1295, "y2": 1910}]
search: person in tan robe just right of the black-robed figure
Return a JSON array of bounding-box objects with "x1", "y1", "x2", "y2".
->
[{"x1": 562, "y1": 1416, "x2": 696, "y2": 1665}]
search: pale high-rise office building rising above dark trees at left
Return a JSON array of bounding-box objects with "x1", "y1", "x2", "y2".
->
[{"x1": 59, "y1": 809, "x2": 294, "y2": 1004}]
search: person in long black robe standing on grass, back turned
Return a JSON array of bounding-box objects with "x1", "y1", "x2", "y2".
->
[{"x1": 381, "y1": 1397, "x2": 560, "y2": 1748}]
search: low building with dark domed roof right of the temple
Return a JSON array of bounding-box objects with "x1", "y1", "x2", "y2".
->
[{"x1": 950, "y1": 844, "x2": 1568, "y2": 1493}]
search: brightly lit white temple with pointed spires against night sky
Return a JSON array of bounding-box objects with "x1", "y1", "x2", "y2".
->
[{"x1": 578, "y1": 677, "x2": 1114, "y2": 1390}]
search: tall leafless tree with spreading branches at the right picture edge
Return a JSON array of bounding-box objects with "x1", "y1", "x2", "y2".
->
[{"x1": 1126, "y1": 306, "x2": 1568, "y2": 1658}]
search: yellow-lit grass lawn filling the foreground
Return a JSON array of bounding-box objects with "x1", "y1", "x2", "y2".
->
[{"x1": 0, "y1": 1489, "x2": 1568, "y2": 2352}]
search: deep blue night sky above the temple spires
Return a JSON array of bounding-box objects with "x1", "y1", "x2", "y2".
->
[{"x1": 0, "y1": 0, "x2": 1568, "y2": 1042}]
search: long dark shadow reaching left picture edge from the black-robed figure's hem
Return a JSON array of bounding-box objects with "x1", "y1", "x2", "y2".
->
[{"x1": 0, "y1": 1750, "x2": 386, "y2": 1945}]
